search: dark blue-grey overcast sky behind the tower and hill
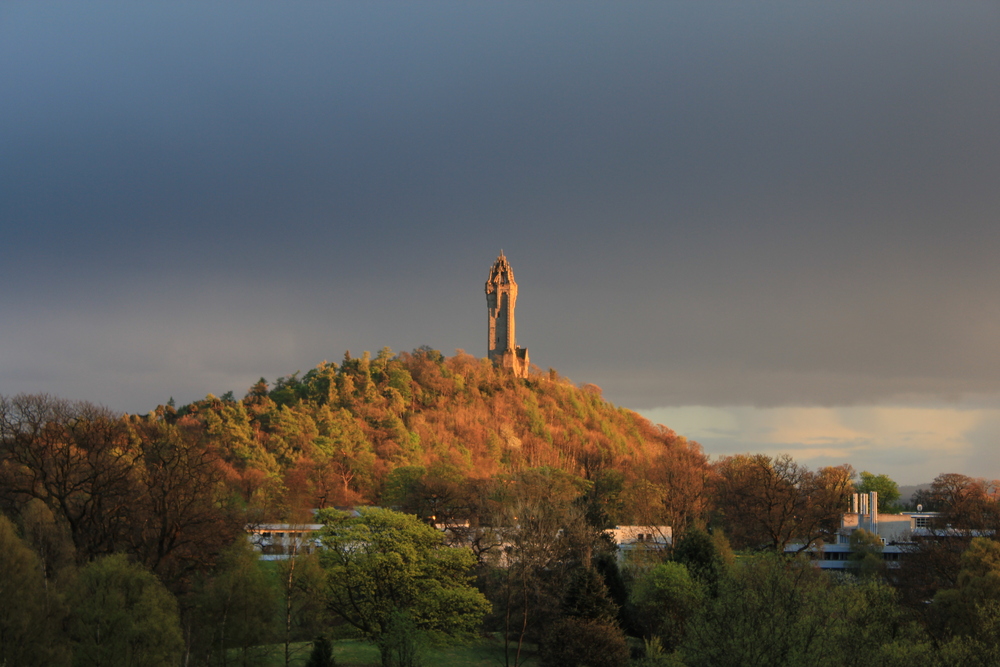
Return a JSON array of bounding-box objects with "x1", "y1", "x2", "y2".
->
[{"x1": 0, "y1": 1, "x2": 1000, "y2": 483}]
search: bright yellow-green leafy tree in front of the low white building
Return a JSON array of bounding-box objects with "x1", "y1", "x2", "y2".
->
[{"x1": 317, "y1": 508, "x2": 489, "y2": 664}]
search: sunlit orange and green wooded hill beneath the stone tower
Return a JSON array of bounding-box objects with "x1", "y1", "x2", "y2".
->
[{"x1": 164, "y1": 348, "x2": 709, "y2": 523}]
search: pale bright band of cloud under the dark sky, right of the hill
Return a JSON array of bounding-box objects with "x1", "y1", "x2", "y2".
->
[{"x1": 642, "y1": 397, "x2": 1000, "y2": 484}]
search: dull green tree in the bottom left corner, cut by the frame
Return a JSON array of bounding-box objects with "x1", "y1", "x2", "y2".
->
[{"x1": 0, "y1": 514, "x2": 68, "y2": 666}]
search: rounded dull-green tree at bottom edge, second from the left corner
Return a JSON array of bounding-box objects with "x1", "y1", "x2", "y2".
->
[{"x1": 69, "y1": 554, "x2": 184, "y2": 667}]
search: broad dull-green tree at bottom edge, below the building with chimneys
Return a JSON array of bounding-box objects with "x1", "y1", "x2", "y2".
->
[{"x1": 680, "y1": 554, "x2": 924, "y2": 667}]
